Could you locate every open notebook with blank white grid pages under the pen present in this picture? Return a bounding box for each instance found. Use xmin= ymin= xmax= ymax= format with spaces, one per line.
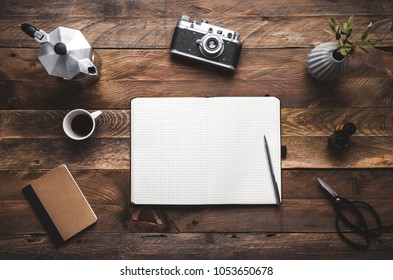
xmin=131 ymin=97 xmax=281 ymax=205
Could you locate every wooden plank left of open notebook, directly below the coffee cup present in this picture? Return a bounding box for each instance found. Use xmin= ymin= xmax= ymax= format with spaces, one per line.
xmin=0 ymin=138 xmax=130 ymax=170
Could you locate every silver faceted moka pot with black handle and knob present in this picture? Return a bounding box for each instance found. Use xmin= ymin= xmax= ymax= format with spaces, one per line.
xmin=21 ymin=23 xmax=101 ymax=88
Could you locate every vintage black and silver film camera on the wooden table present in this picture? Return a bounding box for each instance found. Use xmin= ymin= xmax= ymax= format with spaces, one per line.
xmin=169 ymin=15 xmax=242 ymax=71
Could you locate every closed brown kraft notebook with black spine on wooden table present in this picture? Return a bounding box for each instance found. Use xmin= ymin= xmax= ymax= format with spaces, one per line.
xmin=23 ymin=164 xmax=97 ymax=243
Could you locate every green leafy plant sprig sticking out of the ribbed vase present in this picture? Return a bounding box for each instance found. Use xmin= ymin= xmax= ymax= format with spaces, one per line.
xmin=324 ymin=16 xmax=381 ymax=57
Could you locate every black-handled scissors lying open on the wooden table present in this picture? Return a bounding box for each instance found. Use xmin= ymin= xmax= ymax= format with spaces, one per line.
xmin=317 ymin=178 xmax=382 ymax=249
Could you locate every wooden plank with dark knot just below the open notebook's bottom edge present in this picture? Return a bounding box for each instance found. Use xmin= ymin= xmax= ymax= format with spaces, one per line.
xmin=0 ymin=199 xmax=393 ymax=234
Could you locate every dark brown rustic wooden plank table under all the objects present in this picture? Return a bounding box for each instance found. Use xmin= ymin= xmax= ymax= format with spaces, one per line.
xmin=0 ymin=0 xmax=393 ymax=259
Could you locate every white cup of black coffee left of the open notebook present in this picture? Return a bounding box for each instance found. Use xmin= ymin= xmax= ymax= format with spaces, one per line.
xmin=63 ymin=109 xmax=102 ymax=140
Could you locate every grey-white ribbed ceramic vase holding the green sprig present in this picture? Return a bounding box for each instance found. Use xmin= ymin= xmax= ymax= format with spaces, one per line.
xmin=307 ymin=42 xmax=349 ymax=82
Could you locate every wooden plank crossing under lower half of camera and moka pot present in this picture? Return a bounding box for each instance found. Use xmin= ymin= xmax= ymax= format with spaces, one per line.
xmin=0 ymin=48 xmax=393 ymax=83
